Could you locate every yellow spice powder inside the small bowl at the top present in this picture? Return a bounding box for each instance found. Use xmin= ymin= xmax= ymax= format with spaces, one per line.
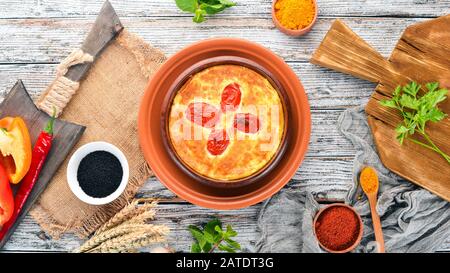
xmin=275 ymin=0 xmax=315 ymax=30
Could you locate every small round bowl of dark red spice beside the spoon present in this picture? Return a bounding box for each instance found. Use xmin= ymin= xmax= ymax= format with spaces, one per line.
xmin=313 ymin=203 xmax=363 ymax=253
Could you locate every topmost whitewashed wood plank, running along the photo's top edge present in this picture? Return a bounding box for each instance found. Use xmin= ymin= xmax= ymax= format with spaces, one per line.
xmin=0 ymin=0 xmax=450 ymax=18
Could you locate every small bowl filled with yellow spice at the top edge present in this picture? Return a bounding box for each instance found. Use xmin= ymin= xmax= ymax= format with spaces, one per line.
xmin=272 ymin=0 xmax=318 ymax=36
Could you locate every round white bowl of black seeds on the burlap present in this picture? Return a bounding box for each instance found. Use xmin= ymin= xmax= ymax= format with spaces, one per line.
xmin=67 ymin=141 xmax=129 ymax=205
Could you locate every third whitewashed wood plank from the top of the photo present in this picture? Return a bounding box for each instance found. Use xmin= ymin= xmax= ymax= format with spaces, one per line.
xmin=0 ymin=63 xmax=375 ymax=109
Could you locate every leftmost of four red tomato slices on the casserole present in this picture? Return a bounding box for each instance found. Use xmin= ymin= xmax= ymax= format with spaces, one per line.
xmin=185 ymin=102 xmax=220 ymax=128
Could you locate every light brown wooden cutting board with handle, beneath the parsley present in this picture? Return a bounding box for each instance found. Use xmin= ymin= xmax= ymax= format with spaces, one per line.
xmin=311 ymin=15 xmax=450 ymax=201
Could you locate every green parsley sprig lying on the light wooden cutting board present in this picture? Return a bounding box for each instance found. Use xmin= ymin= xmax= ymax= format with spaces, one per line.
xmin=380 ymin=82 xmax=450 ymax=164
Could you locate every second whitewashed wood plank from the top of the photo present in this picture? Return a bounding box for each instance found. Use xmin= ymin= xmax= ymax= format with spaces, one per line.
xmin=0 ymin=17 xmax=424 ymax=63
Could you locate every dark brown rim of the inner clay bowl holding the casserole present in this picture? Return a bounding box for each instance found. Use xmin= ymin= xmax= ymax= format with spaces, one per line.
xmin=161 ymin=55 xmax=290 ymax=188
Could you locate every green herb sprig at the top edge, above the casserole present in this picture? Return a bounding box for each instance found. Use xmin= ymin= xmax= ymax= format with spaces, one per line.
xmin=175 ymin=0 xmax=236 ymax=23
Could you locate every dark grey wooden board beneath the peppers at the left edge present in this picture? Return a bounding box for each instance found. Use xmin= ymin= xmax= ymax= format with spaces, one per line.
xmin=0 ymin=81 xmax=85 ymax=248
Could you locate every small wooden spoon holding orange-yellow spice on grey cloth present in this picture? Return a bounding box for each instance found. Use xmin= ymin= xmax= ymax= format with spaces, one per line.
xmin=359 ymin=167 xmax=385 ymax=253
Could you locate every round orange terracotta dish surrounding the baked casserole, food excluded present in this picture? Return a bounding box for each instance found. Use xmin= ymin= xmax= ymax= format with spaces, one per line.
xmin=138 ymin=38 xmax=311 ymax=209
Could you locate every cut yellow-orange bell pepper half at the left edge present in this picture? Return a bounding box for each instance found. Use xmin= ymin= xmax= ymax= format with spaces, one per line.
xmin=0 ymin=117 xmax=31 ymax=184
